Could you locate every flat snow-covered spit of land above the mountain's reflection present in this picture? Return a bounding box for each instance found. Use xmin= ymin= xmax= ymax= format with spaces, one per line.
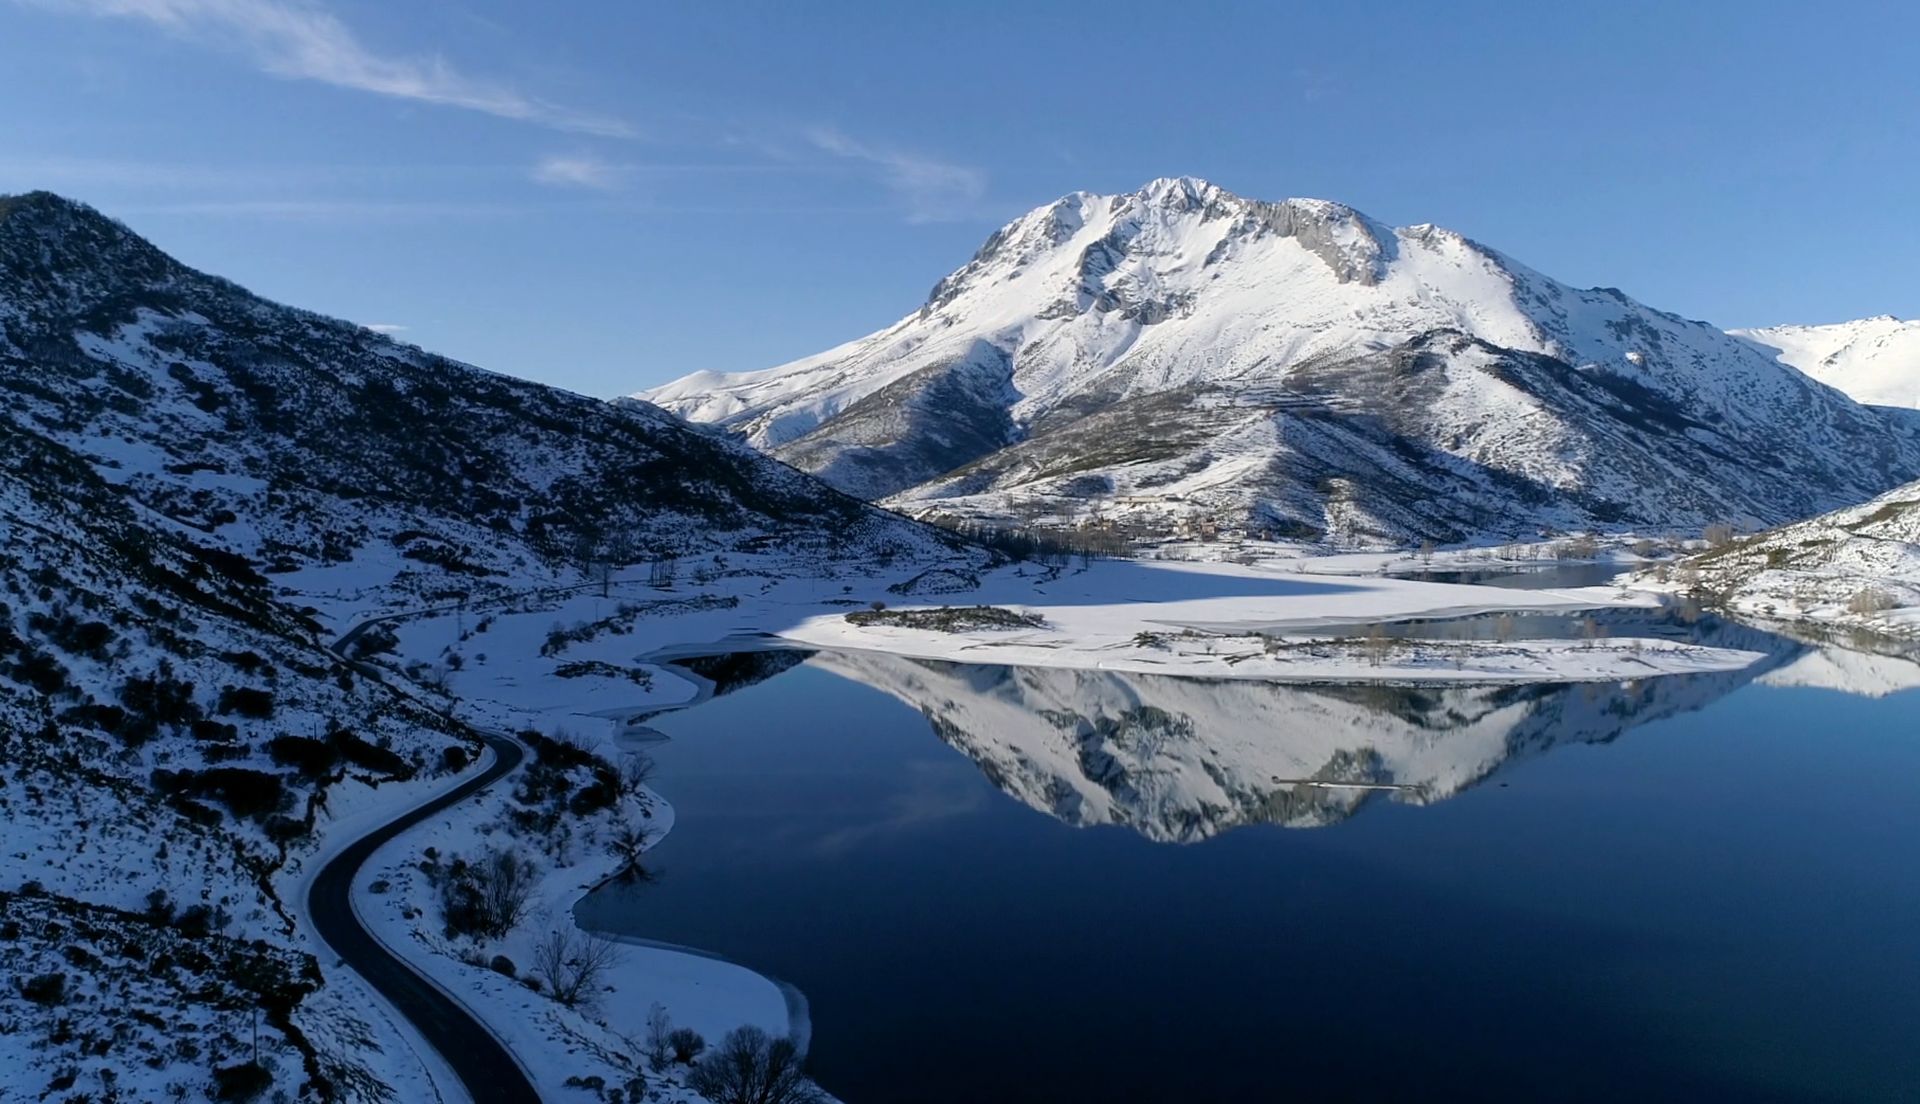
xmin=778 ymin=563 xmax=1759 ymax=682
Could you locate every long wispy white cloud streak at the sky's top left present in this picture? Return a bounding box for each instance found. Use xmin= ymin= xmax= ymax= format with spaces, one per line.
xmin=15 ymin=0 xmax=634 ymax=138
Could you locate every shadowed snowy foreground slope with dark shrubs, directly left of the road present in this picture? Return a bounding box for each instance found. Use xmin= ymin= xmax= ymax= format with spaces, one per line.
xmin=0 ymin=419 xmax=470 ymax=1100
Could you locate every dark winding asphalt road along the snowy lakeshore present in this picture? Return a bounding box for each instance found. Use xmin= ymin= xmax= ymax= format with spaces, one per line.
xmin=307 ymin=622 xmax=540 ymax=1104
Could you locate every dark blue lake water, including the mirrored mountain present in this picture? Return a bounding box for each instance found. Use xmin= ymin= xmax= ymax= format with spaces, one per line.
xmin=582 ymin=643 xmax=1920 ymax=1104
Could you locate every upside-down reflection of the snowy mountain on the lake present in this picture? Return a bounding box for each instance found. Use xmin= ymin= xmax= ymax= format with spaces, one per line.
xmin=810 ymin=624 xmax=1803 ymax=843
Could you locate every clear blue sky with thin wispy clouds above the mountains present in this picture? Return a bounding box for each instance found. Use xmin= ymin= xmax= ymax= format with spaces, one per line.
xmin=0 ymin=0 xmax=1920 ymax=396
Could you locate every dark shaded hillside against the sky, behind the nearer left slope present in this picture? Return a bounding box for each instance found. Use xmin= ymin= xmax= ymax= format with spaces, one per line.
xmin=0 ymin=192 xmax=960 ymax=618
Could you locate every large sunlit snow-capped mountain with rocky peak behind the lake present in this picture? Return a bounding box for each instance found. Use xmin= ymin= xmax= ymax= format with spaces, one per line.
xmin=645 ymin=179 xmax=1920 ymax=541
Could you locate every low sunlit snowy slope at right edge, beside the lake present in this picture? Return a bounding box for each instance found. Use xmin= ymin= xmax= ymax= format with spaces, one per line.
xmin=1653 ymin=482 xmax=1920 ymax=636
